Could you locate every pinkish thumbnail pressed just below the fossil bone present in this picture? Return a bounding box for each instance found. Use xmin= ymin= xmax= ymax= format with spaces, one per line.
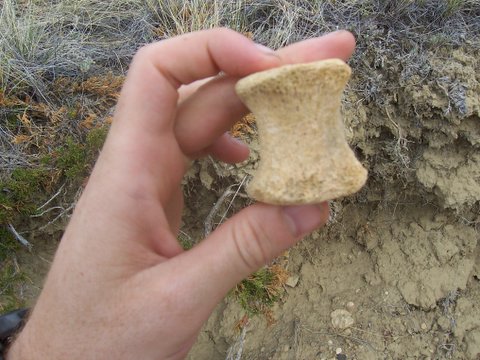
xmin=283 ymin=203 xmax=328 ymax=236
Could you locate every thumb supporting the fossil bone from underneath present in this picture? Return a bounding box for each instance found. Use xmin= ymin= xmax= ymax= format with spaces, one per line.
xmin=183 ymin=202 xmax=329 ymax=301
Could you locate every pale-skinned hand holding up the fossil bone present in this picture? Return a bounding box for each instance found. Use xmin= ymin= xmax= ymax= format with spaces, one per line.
xmin=7 ymin=29 xmax=355 ymax=360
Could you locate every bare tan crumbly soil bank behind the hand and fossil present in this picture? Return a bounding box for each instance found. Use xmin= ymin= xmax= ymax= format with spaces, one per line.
xmin=11 ymin=49 xmax=480 ymax=360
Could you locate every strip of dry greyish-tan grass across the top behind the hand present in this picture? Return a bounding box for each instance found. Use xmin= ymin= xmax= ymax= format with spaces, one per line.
xmin=0 ymin=0 xmax=480 ymax=167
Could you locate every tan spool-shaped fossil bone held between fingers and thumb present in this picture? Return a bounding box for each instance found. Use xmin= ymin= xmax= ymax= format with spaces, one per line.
xmin=236 ymin=59 xmax=367 ymax=205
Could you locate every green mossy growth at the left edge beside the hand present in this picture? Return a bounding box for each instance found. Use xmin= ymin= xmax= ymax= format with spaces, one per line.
xmin=0 ymin=127 xmax=107 ymax=313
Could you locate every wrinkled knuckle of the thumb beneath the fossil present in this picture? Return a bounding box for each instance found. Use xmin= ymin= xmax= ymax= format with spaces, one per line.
xmin=232 ymin=216 xmax=271 ymax=271
